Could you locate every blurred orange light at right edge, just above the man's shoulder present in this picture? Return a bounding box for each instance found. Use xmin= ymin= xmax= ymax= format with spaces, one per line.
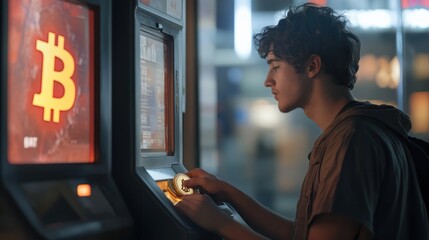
xmin=410 ymin=92 xmax=429 ymax=133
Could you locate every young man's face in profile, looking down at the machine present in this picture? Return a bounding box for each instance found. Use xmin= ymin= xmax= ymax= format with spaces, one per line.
xmin=264 ymin=51 xmax=312 ymax=112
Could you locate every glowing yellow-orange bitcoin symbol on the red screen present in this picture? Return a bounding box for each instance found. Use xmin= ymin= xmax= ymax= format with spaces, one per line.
xmin=33 ymin=32 xmax=76 ymax=123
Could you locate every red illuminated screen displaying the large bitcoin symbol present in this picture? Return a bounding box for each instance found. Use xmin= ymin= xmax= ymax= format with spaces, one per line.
xmin=7 ymin=0 xmax=95 ymax=164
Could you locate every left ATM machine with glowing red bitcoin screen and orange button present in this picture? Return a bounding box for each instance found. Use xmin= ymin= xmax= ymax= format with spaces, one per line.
xmin=0 ymin=0 xmax=133 ymax=239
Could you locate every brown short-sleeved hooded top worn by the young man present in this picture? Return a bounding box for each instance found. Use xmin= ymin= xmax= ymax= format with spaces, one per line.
xmin=292 ymin=104 xmax=429 ymax=240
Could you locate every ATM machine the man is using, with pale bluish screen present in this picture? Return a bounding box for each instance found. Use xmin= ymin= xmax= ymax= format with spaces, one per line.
xmin=112 ymin=0 xmax=233 ymax=239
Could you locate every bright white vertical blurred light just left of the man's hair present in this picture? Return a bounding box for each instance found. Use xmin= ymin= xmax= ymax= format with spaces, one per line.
xmin=234 ymin=0 xmax=252 ymax=59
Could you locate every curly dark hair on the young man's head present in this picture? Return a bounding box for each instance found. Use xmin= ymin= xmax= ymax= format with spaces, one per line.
xmin=253 ymin=3 xmax=361 ymax=89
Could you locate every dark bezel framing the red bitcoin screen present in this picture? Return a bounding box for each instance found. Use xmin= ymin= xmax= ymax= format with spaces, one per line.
xmin=0 ymin=0 xmax=112 ymax=181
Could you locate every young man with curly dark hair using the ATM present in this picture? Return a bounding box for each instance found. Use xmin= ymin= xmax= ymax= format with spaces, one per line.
xmin=176 ymin=4 xmax=429 ymax=240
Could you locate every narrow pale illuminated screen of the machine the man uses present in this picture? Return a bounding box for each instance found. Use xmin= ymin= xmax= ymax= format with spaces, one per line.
xmin=140 ymin=27 xmax=174 ymax=154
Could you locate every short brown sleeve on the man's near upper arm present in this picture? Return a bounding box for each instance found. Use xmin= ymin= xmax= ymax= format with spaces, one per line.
xmin=309 ymin=125 xmax=384 ymax=231
